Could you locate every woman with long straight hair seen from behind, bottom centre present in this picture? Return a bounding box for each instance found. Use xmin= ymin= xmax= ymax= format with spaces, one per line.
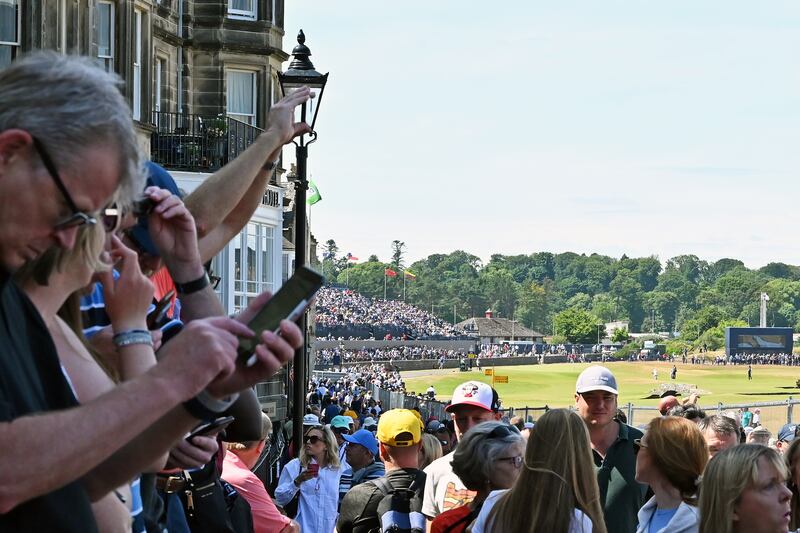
xmin=472 ymin=409 xmax=606 ymax=533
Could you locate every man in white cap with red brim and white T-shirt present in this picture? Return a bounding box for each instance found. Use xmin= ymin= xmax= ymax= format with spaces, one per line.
xmin=422 ymin=381 xmax=501 ymax=529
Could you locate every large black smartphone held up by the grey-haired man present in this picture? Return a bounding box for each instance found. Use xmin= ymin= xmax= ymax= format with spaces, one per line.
xmin=238 ymin=267 xmax=325 ymax=366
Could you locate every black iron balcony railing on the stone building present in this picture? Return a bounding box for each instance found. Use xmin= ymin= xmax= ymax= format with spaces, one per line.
xmin=150 ymin=111 xmax=263 ymax=172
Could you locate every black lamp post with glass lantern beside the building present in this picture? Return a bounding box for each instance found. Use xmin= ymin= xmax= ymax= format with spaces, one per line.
xmin=278 ymin=30 xmax=328 ymax=455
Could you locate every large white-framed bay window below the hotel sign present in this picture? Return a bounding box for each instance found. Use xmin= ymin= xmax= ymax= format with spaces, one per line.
xmin=233 ymin=222 xmax=275 ymax=312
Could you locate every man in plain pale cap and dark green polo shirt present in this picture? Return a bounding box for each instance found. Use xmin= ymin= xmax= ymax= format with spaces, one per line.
xmin=575 ymin=366 xmax=647 ymax=533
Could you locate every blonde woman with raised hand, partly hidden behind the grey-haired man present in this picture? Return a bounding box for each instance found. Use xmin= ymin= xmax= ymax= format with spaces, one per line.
xmin=15 ymin=214 xmax=166 ymax=532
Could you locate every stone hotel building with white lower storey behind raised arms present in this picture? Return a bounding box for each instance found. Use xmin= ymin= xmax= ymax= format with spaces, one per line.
xmin=0 ymin=0 xmax=300 ymax=417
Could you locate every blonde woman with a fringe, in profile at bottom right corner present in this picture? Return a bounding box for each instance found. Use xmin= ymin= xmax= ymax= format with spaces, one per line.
xmin=699 ymin=444 xmax=792 ymax=533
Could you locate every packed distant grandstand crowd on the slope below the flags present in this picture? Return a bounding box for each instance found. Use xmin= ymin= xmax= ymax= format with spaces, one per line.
xmin=316 ymin=287 xmax=458 ymax=338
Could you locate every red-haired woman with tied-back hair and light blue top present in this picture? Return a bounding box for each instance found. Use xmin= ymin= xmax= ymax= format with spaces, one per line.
xmin=634 ymin=416 xmax=708 ymax=533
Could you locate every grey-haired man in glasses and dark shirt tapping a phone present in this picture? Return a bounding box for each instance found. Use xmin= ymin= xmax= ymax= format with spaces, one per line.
xmin=0 ymin=53 xmax=302 ymax=532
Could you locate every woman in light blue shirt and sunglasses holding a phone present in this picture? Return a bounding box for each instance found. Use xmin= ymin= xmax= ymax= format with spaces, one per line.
xmin=275 ymin=426 xmax=342 ymax=532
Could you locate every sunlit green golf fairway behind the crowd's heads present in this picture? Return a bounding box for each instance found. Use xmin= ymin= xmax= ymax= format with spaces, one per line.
xmin=403 ymin=362 xmax=800 ymax=410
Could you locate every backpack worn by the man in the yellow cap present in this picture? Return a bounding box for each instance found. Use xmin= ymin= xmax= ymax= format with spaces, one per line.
xmin=367 ymin=470 xmax=425 ymax=533
